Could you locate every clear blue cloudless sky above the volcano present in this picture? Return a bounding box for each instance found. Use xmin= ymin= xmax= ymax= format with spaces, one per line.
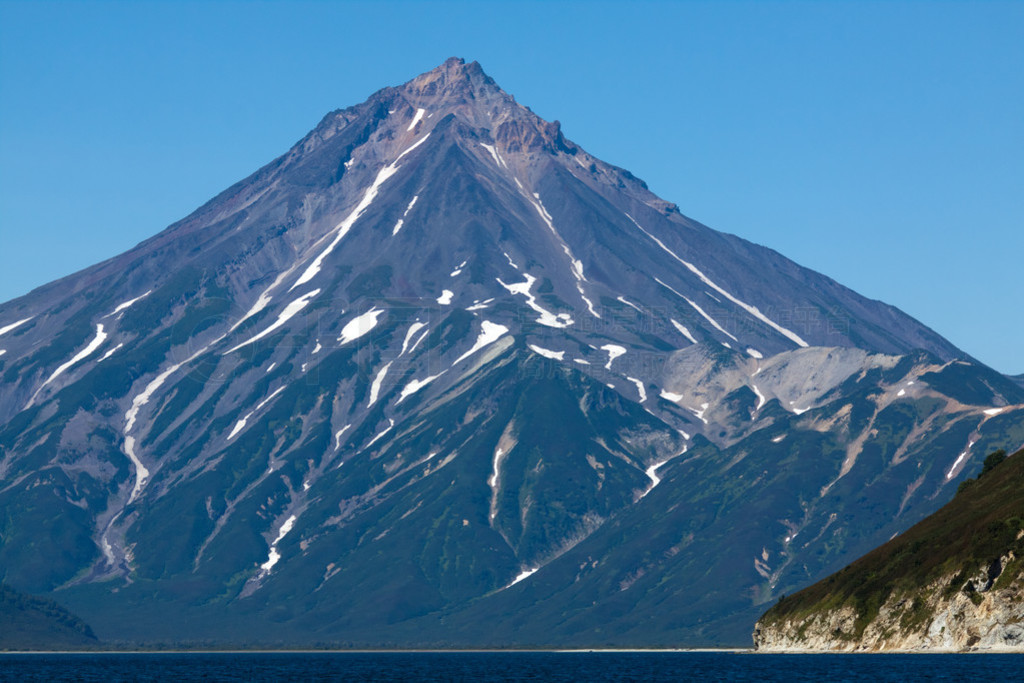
xmin=0 ymin=0 xmax=1024 ymax=373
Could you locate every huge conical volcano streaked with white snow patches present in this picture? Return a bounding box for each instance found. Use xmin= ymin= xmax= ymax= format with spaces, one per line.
xmin=0 ymin=59 xmax=1024 ymax=646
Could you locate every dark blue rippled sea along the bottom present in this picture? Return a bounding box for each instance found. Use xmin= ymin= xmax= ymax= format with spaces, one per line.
xmin=0 ymin=652 xmax=1024 ymax=683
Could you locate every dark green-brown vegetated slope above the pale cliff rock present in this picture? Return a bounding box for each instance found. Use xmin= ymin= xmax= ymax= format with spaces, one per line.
xmin=761 ymin=451 xmax=1024 ymax=635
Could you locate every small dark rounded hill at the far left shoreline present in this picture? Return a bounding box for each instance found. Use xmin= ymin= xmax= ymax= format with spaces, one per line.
xmin=0 ymin=584 xmax=98 ymax=650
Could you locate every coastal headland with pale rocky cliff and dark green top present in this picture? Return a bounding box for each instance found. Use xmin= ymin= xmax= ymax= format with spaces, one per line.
xmin=754 ymin=452 xmax=1024 ymax=652
